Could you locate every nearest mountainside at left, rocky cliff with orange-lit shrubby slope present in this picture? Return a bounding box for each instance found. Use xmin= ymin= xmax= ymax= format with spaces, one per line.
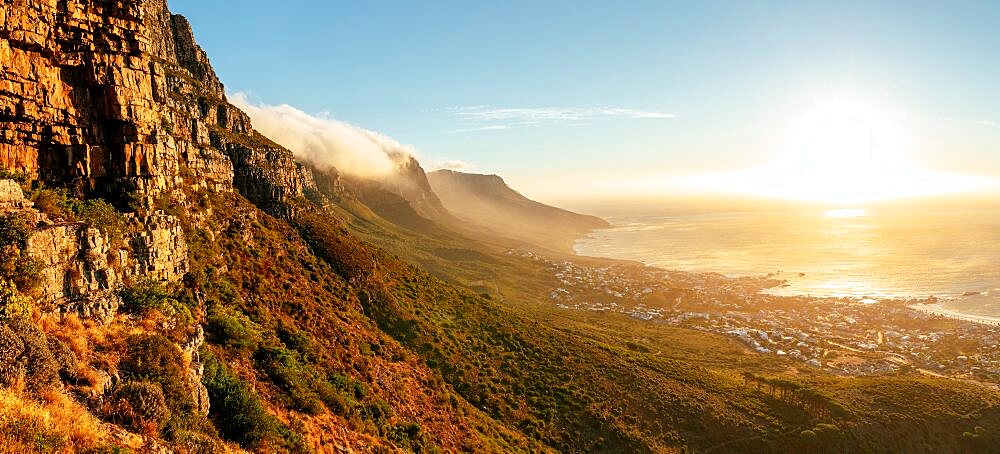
xmin=0 ymin=1 xmax=541 ymax=452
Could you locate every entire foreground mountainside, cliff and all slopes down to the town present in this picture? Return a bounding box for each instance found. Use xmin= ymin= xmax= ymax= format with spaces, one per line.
xmin=0 ymin=0 xmax=1000 ymax=453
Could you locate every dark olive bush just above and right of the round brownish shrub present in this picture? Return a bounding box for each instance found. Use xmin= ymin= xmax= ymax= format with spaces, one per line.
xmin=118 ymin=335 xmax=194 ymax=415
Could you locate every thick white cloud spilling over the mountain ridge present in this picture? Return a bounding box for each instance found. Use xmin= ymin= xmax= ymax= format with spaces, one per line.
xmin=230 ymin=93 xmax=416 ymax=178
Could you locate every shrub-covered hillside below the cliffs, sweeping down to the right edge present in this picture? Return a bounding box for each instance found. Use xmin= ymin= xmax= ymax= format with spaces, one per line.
xmin=0 ymin=168 xmax=1000 ymax=452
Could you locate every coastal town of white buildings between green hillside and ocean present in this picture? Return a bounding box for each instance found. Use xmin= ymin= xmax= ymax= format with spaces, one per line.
xmin=508 ymin=251 xmax=1000 ymax=387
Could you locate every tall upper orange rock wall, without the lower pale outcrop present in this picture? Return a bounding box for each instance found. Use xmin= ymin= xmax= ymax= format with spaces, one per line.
xmin=0 ymin=0 xmax=302 ymax=212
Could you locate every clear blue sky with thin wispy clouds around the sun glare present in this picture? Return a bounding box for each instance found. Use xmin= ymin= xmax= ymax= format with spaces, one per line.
xmin=170 ymin=0 xmax=1000 ymax=199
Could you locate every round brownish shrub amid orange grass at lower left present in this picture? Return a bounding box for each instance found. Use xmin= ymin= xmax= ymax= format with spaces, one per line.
xmin=105 ymin=381 xmax=170 ymax=434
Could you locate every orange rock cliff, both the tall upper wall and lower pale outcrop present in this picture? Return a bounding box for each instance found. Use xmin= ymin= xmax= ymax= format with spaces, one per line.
xmin=0 ymin=0 xmax=308 ymax=319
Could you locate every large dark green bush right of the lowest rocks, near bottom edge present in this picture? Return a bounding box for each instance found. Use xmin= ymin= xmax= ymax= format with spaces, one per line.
xmin=201 ymin=349 xmax=280 ymax=448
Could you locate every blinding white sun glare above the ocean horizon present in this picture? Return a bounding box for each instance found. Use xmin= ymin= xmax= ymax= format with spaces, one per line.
xmin=686 ymin=100 xmax=987 ymax=204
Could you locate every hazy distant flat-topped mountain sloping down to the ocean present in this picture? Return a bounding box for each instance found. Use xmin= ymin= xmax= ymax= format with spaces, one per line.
xmin=427 ymin=170 xmax=610 ymax=251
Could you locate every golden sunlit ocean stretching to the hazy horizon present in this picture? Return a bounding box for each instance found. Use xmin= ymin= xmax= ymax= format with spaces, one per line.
xmin=576 ymin=200 xmax=1000 ymax=317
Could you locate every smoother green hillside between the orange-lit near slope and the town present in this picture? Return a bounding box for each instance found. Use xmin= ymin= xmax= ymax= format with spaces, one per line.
xmin=306 ymin=183 xmax=998 ymax=452
